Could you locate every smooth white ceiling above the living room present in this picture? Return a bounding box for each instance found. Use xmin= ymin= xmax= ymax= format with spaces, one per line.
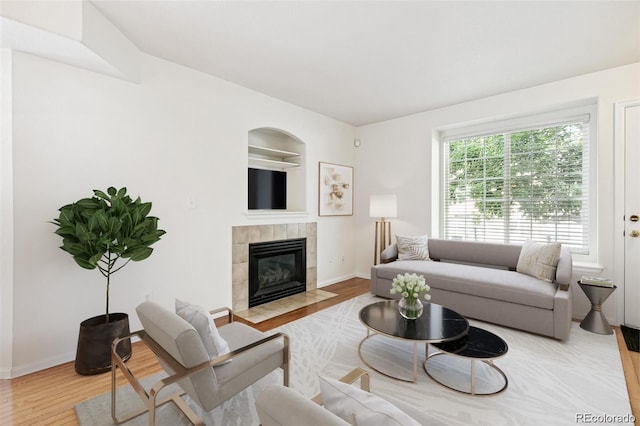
xmin=91 ymin=0 xmax=640 ymax=126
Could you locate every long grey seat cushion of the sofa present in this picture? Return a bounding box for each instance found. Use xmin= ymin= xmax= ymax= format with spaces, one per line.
xmin=376 ymin=260 xmax=556 ymax=309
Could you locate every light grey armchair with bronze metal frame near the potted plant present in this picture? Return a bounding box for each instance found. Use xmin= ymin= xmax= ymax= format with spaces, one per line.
xmin=111 ymin=302 xmax=290 ymax=425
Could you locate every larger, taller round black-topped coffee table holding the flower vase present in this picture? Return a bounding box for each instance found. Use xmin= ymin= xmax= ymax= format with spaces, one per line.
xmin=358 ymin=300 xmax=469 ymax=383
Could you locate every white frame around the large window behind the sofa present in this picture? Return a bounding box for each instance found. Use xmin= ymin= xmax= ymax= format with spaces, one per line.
xmin=433 ymin=104 xmax=598 ymax=262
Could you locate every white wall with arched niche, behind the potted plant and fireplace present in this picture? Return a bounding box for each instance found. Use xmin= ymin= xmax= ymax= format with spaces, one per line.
xmin=0 ymin=52 xmax=356 ymax=377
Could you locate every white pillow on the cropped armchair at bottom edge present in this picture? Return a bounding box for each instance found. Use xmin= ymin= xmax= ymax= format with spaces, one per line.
xmin=320 ymin=376 xmax=420 ymax=426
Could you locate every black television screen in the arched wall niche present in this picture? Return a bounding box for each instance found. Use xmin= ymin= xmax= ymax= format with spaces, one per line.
xmin=249 ymin=168 xmax=287 ymax=210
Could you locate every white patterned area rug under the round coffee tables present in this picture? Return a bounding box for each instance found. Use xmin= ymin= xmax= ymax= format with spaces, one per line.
xmin=76 ymin=295 xmax=631 ymax=426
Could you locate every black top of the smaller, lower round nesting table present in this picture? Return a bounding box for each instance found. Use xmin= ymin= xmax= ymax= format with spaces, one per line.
xmin=433 ymin=326 xmax=509 ymax=359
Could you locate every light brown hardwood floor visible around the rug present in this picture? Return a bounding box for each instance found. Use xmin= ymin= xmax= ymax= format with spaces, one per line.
xmin=0 ymin=278 xmax=640 ymax=425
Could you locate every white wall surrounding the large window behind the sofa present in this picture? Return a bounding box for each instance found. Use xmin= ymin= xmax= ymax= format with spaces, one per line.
xmin=356 ymin=64 xmax=640 ymax=324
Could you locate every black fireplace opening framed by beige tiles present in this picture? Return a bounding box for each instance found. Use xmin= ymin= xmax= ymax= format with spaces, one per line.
xmin=249 ymin=238 xmax=307 ymax=308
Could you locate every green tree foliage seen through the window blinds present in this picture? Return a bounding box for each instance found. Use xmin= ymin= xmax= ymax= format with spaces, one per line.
xmin=448 ymin=123 xmax=583 ymax=221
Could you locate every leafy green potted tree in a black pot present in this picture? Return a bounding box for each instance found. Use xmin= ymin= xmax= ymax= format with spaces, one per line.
xmin=51 ymin=187 xmax=165 ymax=375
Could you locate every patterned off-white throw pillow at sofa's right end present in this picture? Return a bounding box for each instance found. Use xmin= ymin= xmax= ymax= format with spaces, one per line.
xmin=516 ymin=241 xmax=562 ymax=283
